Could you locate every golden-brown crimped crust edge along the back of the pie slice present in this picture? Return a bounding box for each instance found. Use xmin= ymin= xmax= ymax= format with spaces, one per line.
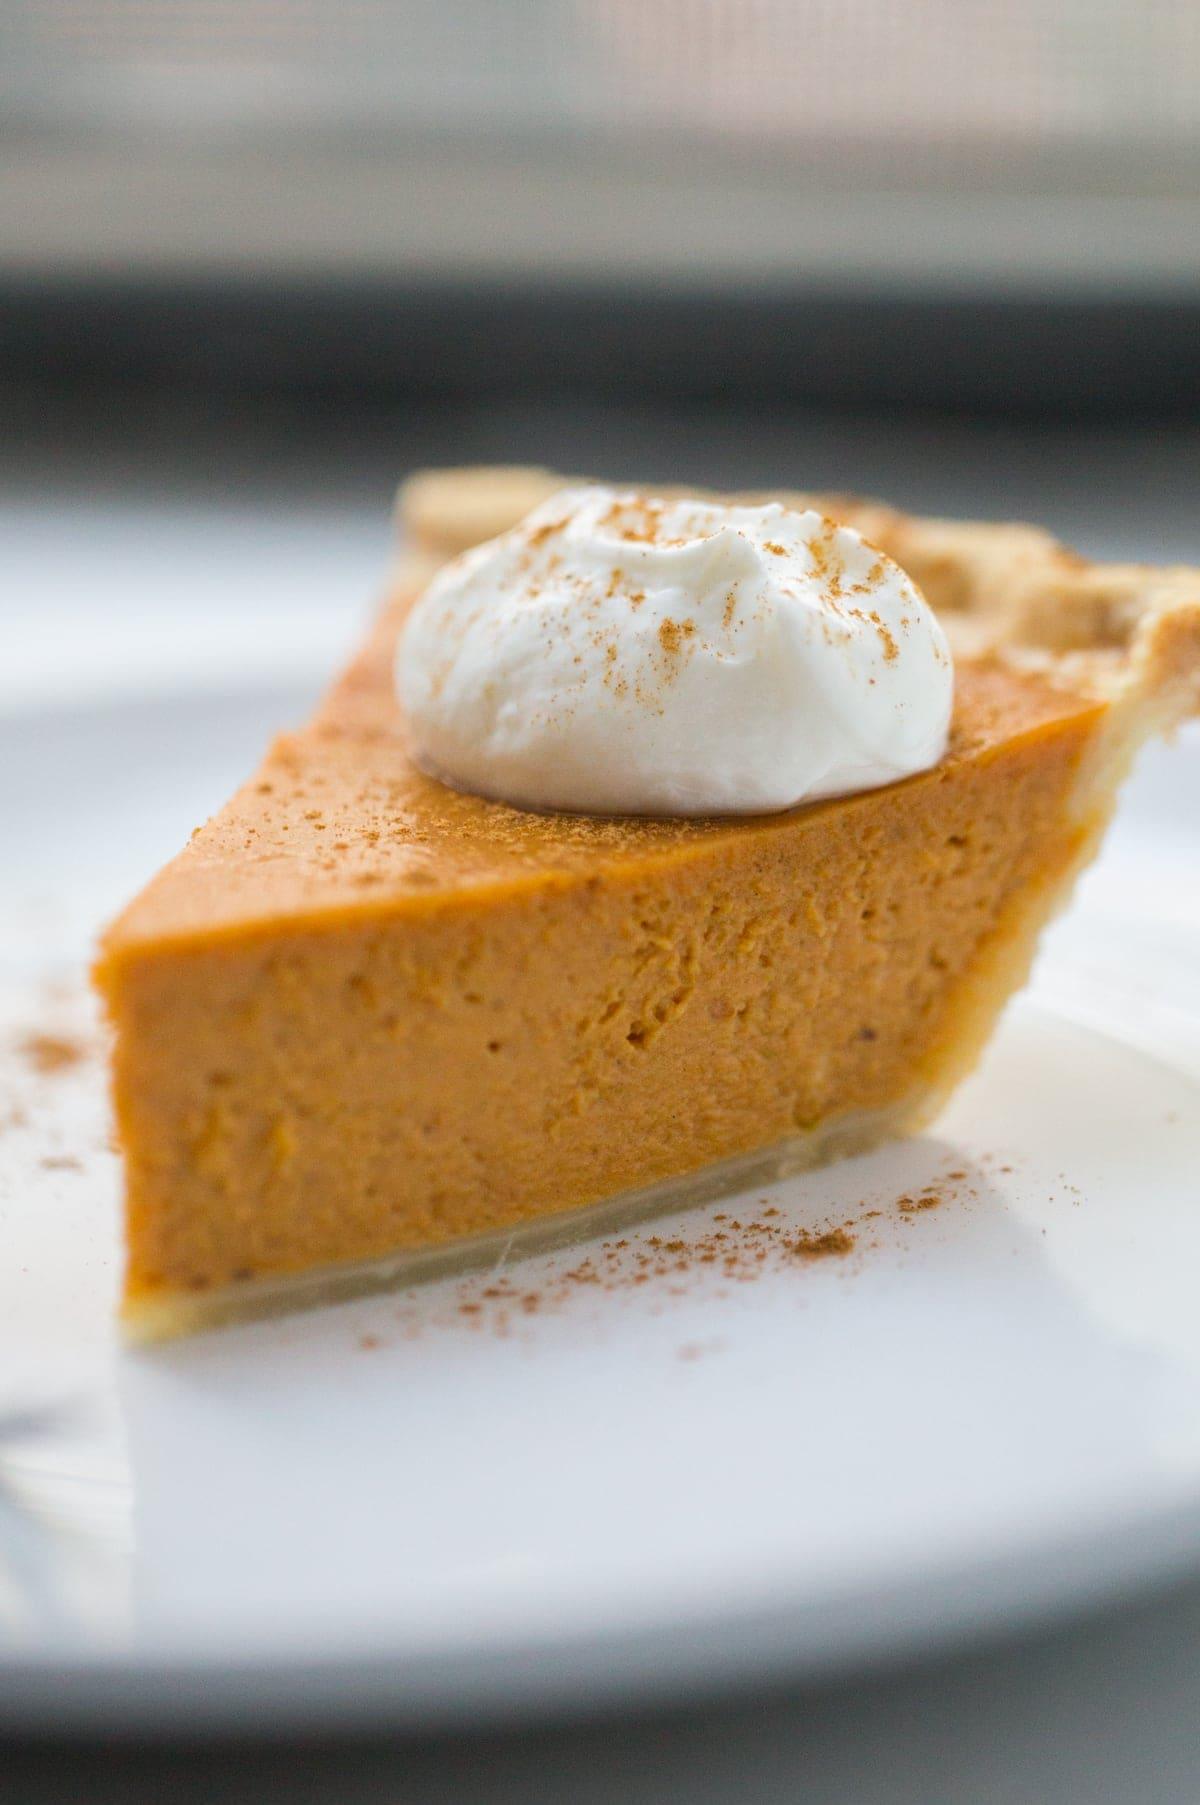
xmin=397 ymin=464 xmax=1200 ymax=733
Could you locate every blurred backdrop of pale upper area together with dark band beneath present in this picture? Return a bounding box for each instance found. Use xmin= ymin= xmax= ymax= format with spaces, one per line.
xmin=0 ymin=0 xmax=1200 ymax=400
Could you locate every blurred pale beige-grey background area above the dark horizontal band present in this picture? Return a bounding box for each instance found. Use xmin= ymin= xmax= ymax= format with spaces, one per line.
xmin=0 ymin=0 xmax=1200 ymax=292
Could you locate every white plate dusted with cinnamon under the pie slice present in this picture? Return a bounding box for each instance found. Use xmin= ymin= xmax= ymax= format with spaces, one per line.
xmin=0 ymin=695 xmax=1200 ymax=1727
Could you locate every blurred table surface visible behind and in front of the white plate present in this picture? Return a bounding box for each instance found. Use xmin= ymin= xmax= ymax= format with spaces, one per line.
xmin=9 ymin=395 xmax=1200 ymax=1805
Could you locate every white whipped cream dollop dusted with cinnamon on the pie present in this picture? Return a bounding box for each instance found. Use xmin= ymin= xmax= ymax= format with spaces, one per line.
xmin=397 ymin=487 xmax=953 ymax=814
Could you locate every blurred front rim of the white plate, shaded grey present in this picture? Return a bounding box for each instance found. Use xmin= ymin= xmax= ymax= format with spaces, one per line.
xmin=0 ymin=1496 xmax=1200 ymax=1736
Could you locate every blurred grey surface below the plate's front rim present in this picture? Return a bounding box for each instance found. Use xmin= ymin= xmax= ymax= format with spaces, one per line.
xmin=0 ymin=1583 xmax=1200 ymax=1805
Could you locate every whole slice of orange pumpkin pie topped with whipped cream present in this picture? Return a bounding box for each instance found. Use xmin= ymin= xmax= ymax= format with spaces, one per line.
xmin=96 ymin=469 xmax=1200 ymax=1336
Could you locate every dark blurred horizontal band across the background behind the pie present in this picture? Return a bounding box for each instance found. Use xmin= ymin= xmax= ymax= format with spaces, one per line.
xmin=0 ymin=276 xmax=1200 ymax=419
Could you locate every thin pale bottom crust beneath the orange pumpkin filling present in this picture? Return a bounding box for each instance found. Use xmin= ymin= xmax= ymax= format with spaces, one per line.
xmin=121 ymin=1092 xmax=923 ymax=1345
